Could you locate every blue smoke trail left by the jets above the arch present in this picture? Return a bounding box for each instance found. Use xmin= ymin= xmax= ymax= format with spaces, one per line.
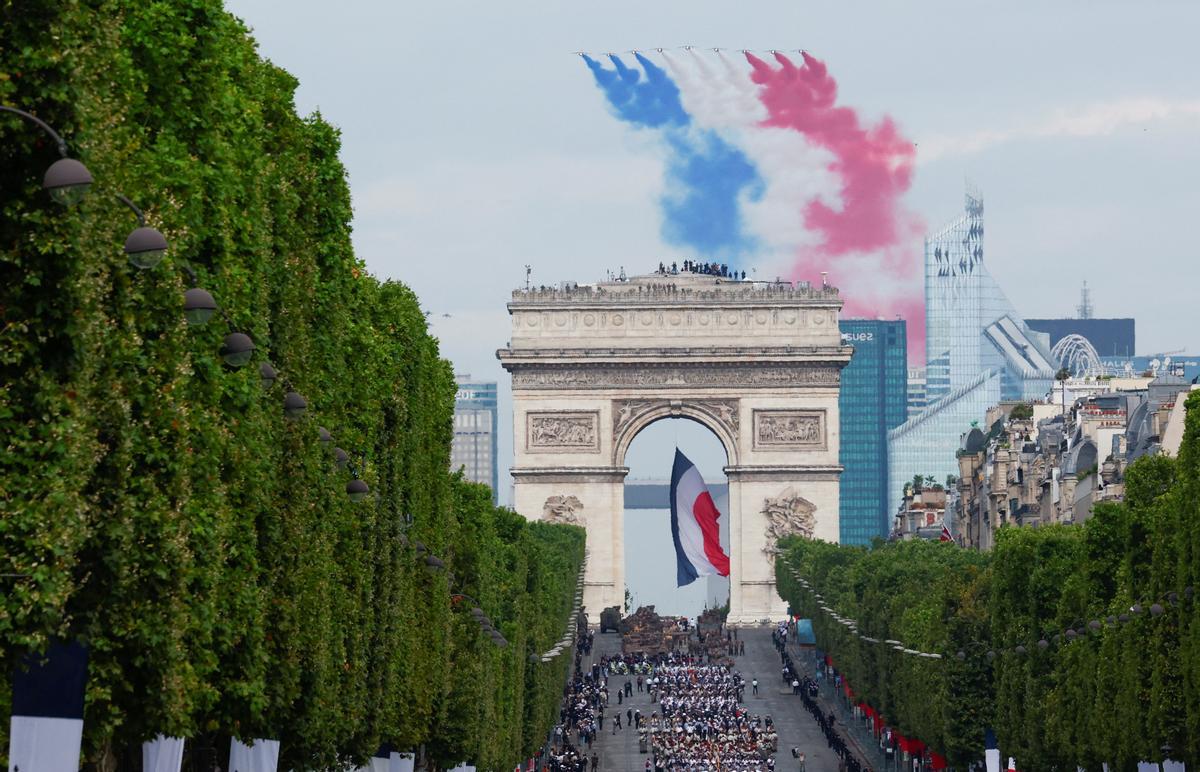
xmin=583 ymin=54 xmax=763 ymax=264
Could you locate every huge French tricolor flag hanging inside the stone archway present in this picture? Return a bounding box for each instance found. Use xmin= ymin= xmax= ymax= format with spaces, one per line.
xmin=671 ymin=448 xmax=730 ymax=587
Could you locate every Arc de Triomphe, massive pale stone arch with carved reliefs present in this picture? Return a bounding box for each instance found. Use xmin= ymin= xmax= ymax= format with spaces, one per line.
xmin=497 ymin=274 xmax=851 ymax=622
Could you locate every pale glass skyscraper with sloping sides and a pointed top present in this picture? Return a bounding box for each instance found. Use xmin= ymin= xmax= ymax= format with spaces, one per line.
xmin=888 ymin=192 xmax=1056 ymax=509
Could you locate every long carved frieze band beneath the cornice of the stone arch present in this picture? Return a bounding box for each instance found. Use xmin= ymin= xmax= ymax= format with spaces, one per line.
xmin=512 ymin=363 xmax=841 ymax=389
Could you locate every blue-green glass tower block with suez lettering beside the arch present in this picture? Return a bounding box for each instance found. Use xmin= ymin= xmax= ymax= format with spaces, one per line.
xmin=838 ymin=319 xmax=908 ymax=544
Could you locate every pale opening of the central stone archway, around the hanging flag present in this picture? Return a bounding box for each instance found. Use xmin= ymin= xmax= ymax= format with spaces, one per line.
xmin=624 ymin=418 xmax=730 ymax=618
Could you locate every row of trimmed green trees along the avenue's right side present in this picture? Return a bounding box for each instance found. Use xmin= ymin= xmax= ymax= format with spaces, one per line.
xmin=778 ymin=393 xmax=1200 ymax=770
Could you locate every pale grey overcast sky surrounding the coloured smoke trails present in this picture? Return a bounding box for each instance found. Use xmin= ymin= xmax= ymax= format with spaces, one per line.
xmin=228 ymin=0 xmax=1200 ymax=504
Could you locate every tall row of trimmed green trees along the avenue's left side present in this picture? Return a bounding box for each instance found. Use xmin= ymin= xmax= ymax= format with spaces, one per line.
xmin=0 ymin=0 xmax=583 ymax=770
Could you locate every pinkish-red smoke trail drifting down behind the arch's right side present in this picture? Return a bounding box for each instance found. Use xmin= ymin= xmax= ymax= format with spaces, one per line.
xmin=746 ymin=53 xmax=925 ymax=363
